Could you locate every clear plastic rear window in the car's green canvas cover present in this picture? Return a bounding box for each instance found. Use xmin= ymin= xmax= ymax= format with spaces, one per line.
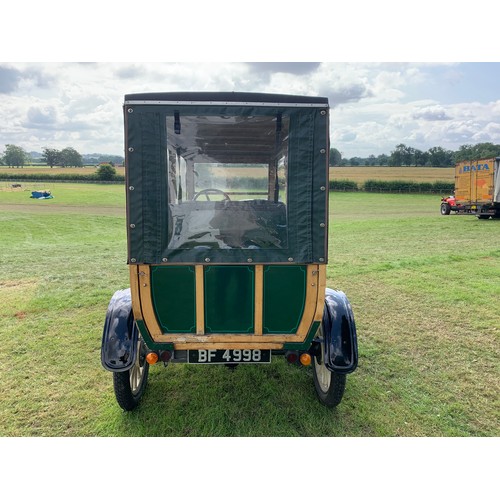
xmin=167 ymin=113 xmax=289 ymax=249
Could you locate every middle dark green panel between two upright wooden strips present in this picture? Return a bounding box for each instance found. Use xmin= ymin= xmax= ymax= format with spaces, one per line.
xmin=204 ymin=266 xmax=255 ymax=333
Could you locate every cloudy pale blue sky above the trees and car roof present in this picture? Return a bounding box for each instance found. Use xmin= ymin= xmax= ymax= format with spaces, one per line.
xmin=0 ymin=62 xmax=500 ymax=157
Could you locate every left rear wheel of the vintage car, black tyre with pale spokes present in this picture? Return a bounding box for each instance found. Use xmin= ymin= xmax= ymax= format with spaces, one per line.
xmin=113 ymin=338 xmax=149 ymax=411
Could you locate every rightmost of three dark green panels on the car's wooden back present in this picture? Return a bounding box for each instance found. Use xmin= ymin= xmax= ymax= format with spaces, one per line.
xmin=263 ymin=265 xmax=307 ymax=334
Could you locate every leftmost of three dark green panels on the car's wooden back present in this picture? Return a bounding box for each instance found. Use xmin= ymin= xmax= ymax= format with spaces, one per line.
xmin=151 ymin=266 xmax=196 ymax=333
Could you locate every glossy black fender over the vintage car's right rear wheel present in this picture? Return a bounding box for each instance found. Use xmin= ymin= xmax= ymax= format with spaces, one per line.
xmin=322 ymin=288 xmax=358 ymax=373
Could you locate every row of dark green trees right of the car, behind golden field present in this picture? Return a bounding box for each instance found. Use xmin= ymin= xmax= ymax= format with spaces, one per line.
xmin=330 ymin=142 xmax=500 ymax=167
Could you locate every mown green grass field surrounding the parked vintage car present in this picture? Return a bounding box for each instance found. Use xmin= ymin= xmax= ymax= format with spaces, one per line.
xmin=0 ymin=184 xmax=500 ymax=436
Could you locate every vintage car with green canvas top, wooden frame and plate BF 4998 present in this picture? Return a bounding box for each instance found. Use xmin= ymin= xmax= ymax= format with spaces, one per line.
xmin=101 ymin=92 xmax=358 ymax=411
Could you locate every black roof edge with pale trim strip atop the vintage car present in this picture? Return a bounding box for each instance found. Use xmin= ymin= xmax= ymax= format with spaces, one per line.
xmin=124 ymin=92 xmax=328 ymax=107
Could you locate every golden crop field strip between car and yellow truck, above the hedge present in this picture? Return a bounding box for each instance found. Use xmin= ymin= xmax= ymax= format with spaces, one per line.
xmin=330 ymin=167 xmax=455 ymax=187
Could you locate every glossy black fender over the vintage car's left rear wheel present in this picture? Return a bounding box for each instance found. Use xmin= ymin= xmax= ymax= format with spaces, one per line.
xmin=101 ymin=288 xmax=139 ymax=372
